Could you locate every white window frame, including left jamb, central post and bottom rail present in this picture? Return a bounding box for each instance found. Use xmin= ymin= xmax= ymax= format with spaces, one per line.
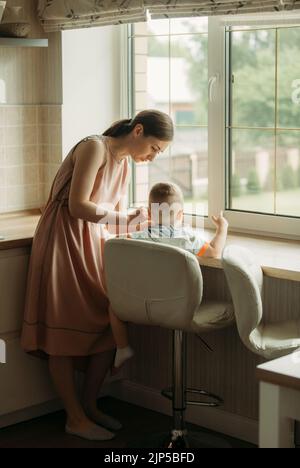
xmin=120 ymin=14 xmax=300 ymax=240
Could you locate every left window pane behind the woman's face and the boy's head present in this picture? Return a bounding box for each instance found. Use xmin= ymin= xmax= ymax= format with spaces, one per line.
xmin=130 ymin=18 xmax=208 ymax=215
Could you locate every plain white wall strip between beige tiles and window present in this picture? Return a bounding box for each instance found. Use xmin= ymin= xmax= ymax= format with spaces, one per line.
xmin=62 ymin=26 xmax=120 ymax=156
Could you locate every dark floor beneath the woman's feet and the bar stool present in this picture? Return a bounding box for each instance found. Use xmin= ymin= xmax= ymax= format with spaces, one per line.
xmin=0 ymin=398 xmax=256 ymax=448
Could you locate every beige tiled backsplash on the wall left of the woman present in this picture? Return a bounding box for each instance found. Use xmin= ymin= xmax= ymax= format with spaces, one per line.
xmin=0 ymin=105 xmax=62 ymax=213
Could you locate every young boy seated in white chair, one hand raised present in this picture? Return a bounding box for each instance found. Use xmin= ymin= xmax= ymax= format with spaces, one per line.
xmin=110 ymin=183 xmax=228 ymax=370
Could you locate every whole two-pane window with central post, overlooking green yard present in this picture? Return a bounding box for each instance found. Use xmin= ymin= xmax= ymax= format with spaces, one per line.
xmin=128 ymin=15 xmax=300 ymax=237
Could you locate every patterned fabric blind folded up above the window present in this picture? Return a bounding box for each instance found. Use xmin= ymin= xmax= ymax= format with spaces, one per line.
xmin=38 ymin=0 xmax=300 ymax=32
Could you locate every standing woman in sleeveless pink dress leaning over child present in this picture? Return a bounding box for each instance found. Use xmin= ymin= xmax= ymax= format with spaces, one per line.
xmin=22 ymin=110 xmax=174 ymax=440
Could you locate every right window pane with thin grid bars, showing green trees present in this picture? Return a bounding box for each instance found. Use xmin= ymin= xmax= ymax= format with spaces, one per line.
xmin=227 ymin=23 xmax=300 ymax=217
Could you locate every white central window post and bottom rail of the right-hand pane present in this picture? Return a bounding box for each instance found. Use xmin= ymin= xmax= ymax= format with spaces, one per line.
xmin=206 ymin=16 xmax=300 ymax=239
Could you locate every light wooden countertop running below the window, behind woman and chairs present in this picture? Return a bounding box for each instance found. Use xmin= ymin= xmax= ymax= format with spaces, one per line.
xmin=0 ymin=210 xmax=300 ymax=282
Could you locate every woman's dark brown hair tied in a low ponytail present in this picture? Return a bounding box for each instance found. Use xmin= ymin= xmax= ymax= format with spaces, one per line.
xmin=103 ymin=110 xmax=174 ymax=141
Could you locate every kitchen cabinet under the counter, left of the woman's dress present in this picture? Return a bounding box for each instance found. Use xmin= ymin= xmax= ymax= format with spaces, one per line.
xmin=0 ymin=248 xmax=56 ymax=428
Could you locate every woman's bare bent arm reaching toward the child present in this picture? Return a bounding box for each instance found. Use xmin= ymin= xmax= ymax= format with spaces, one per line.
xmin=69 ymin=140 xmax=127 ymax=224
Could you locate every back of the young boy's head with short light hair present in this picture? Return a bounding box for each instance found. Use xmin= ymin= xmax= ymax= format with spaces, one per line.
xmin=149 ymin=182 xmax=184 ymax=226
